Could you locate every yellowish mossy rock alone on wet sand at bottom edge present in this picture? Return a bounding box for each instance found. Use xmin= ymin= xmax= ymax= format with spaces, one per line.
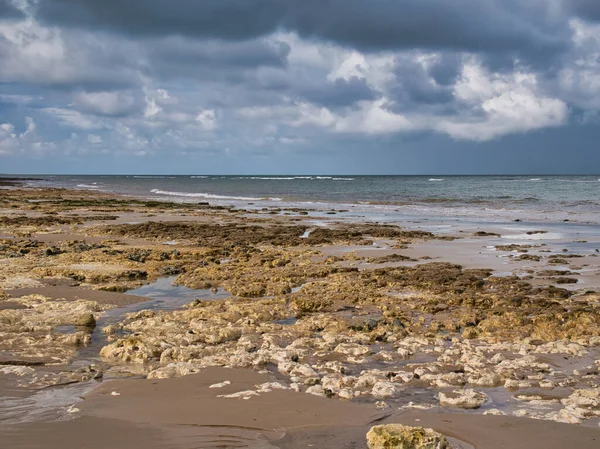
xmin=367 ymin=424 xmax=450 ymax=449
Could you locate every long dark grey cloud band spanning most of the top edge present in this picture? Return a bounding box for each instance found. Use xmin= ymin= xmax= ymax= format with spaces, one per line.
xmin=38 ymin=0 xmax=569 ymax=56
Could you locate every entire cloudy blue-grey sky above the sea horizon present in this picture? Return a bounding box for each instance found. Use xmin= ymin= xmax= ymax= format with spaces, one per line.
xmin=0 ymin=0 xmax=600 ymax=174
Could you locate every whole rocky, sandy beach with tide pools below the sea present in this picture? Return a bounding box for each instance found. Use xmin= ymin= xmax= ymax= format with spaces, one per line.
xmin=0 ymin=185 xmax=600 ymax=449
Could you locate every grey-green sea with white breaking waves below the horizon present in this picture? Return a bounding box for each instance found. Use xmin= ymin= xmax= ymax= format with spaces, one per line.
xmin=7 ymin=175 xmax=600 ymax=223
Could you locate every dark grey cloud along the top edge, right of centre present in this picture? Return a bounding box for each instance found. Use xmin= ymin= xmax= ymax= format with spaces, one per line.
xmin=286 ymin=0 xmax=565 ymax=57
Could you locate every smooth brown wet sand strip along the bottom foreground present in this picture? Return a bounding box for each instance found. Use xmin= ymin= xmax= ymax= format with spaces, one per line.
xmin=0 ymin=368 xmax=600 ymax=449
